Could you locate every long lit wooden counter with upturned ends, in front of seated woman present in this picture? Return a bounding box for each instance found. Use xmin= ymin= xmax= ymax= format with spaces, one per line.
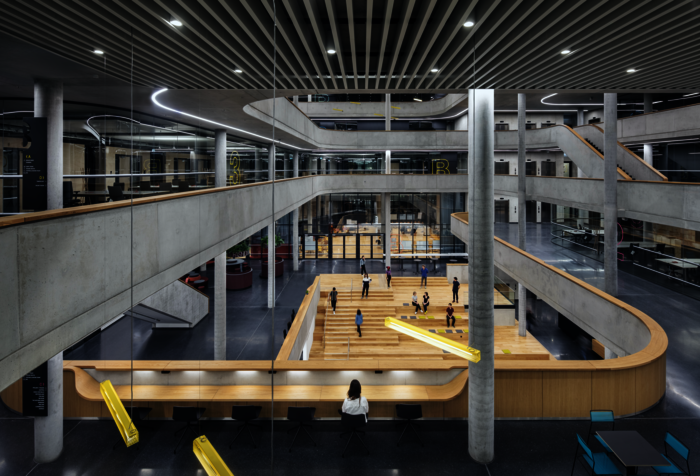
xmin=63 ymin=366 xmax=469 ymax=402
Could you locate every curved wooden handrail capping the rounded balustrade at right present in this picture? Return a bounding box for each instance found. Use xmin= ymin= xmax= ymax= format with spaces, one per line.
xmin=452 ymin=212 xmax=668 ymax=371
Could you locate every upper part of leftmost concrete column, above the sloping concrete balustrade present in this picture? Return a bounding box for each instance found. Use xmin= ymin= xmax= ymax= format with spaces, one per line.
xmin=34 ymin=79 xmax=63 ymax=210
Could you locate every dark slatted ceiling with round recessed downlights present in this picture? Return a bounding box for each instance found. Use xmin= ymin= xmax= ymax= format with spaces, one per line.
xmin=0 ymin=0 xmax=700 ymax=94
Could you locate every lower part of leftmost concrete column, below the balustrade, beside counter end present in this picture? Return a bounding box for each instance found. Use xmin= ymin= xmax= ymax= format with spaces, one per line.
xmin=34 ymin=352 xmax=63 ymax=463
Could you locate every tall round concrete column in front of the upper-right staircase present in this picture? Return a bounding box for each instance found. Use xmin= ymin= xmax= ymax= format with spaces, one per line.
xmin=603 ymin=93 xmax=617 ymax=296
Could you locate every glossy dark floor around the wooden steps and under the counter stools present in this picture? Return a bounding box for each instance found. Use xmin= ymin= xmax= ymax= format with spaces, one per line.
xmin=0 ymin=224 xmax=700 ymax=476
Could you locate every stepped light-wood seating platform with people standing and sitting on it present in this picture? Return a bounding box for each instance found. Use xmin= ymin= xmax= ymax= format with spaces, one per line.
xmin=309 ymin=273 xmax=554 ymax=361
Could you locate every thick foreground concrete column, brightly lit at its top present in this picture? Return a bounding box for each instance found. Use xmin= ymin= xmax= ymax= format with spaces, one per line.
xmin=468 ymin=89 xmax=494 ymax=464
